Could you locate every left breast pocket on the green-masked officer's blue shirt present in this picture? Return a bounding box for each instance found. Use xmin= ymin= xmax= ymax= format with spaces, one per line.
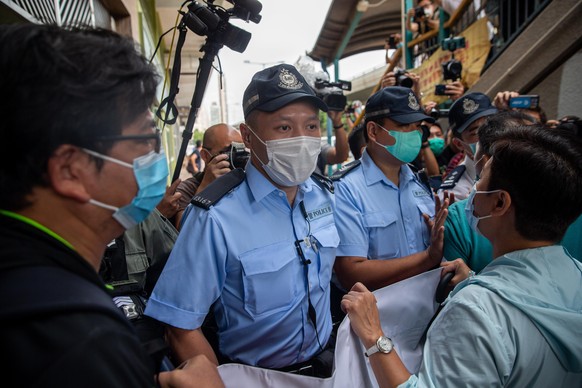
xmin=364 ymin=212 xmax=402 ymax=259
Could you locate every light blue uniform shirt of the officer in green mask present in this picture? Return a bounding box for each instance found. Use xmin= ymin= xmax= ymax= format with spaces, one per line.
xmin=335 ymin=151 xmax=434 ymax=260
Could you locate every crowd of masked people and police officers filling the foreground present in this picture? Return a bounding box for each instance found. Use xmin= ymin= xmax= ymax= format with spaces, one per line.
xmin=0 ymin=25 xmax=582 ymax=387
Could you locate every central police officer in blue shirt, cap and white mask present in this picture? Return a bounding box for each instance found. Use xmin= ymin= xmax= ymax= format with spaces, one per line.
xmin=146 ymin=64 xmax=339 ymax=376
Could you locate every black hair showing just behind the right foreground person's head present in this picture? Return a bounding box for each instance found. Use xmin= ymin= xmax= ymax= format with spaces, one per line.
xmin=478 ymin=110 xmax=535 ymax=156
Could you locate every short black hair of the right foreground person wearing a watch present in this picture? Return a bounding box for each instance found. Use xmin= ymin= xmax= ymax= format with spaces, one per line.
xmin=487 ymin=124 xmax=582 ymax=242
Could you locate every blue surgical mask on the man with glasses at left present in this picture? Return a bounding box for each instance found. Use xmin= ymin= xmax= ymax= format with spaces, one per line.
xmin=83 ymin=149 xmax=168 ymax=229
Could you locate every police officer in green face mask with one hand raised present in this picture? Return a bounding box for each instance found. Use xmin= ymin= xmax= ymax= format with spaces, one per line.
xmin=332 ymin=86 xmax=448 ymax=290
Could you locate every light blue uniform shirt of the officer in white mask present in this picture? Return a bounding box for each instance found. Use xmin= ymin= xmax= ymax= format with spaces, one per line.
xmin=146 ymin=163 xmax=339 ymax=368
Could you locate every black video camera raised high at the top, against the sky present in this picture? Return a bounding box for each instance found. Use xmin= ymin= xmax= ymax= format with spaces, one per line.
xmin=180 ymin=0 xmax=263 ymax=53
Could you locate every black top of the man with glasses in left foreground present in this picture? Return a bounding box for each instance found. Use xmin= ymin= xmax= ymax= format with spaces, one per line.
xmin=0 ymin=214 xmax=154 ymax=387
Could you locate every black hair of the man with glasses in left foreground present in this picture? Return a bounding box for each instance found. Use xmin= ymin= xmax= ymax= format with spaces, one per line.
xmin=0 ymin=24 xmax=158 ymax=210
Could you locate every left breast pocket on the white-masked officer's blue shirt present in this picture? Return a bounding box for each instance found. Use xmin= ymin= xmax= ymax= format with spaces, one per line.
xmin=239 ymin=241 xmax=303 ymax=316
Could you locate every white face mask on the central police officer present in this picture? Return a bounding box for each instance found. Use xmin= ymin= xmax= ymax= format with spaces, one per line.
xmin=247 ymin=125 xmax=321 ymax=187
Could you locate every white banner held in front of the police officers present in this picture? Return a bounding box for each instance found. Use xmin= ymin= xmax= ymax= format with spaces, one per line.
xmin=218 ymin=268 xmax=441 ymax=388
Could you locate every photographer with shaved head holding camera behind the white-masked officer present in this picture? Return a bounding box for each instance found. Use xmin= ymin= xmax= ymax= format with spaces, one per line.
xmin=174 ymin=124 xmax=244 ymax=230
